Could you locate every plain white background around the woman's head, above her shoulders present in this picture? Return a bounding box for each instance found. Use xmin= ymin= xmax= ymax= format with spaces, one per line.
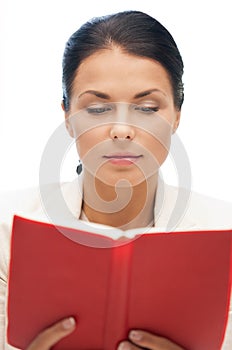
xmin=0 ymin=0 xmax=232 ymax=201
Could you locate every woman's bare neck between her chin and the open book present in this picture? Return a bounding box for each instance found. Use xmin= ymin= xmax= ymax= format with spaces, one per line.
xmin=82 ymin=172 xmax=158 ymax=230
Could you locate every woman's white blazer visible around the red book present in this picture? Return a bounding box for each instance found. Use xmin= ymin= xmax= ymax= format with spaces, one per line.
xmin=0 ymin=176 xmax=232 ymax=350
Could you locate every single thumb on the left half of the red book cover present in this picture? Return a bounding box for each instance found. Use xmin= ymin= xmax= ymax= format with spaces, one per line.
xmin=27 ymin=317 xmax=76 ymax=350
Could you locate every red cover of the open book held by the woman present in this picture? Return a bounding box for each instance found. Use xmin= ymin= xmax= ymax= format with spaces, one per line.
xmin=7 ymin=217 xmax=232 ymax=350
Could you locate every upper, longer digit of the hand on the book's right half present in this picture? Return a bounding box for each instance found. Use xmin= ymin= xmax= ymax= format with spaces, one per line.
xmin=129 ymin=330 xmax=184 ymax=350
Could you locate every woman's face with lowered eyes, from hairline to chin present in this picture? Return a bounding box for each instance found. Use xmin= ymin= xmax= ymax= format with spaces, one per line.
xmin=66 ymin=48 xmax=180 ymax=185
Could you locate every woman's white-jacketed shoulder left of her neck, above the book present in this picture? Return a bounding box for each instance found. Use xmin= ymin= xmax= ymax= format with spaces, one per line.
xmin=0 ymin=181 xmax=82 ymax=247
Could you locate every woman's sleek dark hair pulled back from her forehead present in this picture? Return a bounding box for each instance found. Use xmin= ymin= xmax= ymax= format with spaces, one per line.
xmin=63 ymin=11 xmax=184 ymax=111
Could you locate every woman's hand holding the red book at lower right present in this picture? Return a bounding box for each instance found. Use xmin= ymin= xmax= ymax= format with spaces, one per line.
xmin=118 ymin=330 xmax=184 ymax=350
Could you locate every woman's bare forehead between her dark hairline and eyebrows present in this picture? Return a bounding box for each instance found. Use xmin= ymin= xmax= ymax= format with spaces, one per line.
xmin=72 ymin=48 xmax=172 ymax=95
